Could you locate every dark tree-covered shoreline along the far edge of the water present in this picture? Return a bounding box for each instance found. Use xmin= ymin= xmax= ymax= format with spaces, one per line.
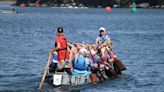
xmin=17 ymin=0 xmax=164 ymax=7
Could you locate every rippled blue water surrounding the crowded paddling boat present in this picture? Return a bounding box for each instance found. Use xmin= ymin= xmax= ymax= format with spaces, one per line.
xmin=0 ymin=6 xmax=164 ymax=92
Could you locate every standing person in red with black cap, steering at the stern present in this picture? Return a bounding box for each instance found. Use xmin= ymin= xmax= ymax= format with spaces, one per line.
xmin=53 ymin=27 xmax=69 ymax=70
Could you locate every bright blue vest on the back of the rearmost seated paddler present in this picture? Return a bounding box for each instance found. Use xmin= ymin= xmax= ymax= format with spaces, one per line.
xmin=73 ymin=55 xmax=90 ymax=70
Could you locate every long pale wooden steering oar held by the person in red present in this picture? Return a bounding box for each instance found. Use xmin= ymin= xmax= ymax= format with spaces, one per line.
xmin=38 ymin=49 xmax=52 ymax=90
